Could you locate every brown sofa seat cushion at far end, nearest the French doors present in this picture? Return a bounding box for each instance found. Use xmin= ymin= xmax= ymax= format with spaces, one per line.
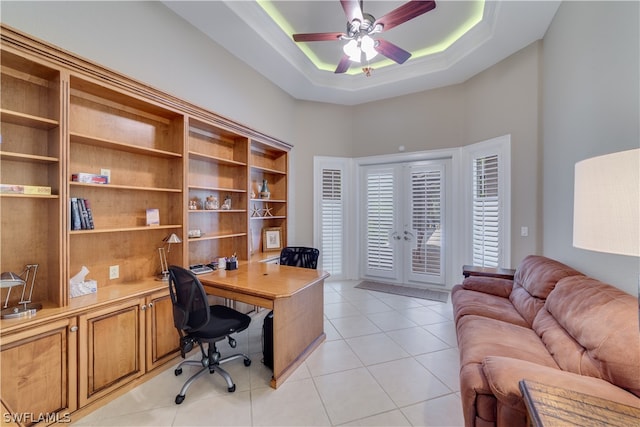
xmin=451 ymin=285 xmax=529 ymax=327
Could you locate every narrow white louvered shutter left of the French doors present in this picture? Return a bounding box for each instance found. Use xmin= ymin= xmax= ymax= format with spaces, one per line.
xmin=320 ymin=169 xmax=344 ymax=276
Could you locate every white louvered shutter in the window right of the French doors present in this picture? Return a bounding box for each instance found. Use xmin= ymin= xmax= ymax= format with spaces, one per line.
xmin=472 ymin=154 xmax=502 ymax=267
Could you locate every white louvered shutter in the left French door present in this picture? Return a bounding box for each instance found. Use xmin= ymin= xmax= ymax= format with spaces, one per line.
xmin=366 ymin=170 xmax=395 ymax=272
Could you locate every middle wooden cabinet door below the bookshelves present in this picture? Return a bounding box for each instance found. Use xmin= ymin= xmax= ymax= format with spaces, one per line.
xmin=79 ymin=298 xmax=146 ymax=406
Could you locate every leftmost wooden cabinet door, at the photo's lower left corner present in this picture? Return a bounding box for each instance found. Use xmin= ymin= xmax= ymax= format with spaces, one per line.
xmin=0 ymin=318 xmax=77 ymax=425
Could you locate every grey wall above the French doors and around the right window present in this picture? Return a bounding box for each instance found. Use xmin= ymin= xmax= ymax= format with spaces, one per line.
xmin=353 ymin=42 xmax=542 ymax=267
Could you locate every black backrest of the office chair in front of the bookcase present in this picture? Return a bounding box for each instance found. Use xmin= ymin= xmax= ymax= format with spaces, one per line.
xmin=169 ymin=265 xmax=210 ymax=332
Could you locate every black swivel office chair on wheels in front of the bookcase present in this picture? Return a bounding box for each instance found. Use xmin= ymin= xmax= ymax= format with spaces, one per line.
xmin=169 ymin=265 xmax=251 ymax=405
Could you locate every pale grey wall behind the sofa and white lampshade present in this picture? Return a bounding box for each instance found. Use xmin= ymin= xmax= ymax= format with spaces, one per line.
xmin=543 ymin=1 xmax=640 ymax=295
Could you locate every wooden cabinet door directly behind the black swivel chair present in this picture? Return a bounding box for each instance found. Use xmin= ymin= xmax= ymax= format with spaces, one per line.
xmin=146 ymin=289 xmax=180 ymax=371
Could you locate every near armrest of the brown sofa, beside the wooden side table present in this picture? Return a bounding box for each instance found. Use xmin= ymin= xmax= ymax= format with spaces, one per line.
xmin=482 ymin=356 xmax=640 ymax=411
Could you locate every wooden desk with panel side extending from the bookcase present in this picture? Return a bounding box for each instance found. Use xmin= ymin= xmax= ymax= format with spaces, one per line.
xmin=198 ymin=262 xmax=329 ymax=388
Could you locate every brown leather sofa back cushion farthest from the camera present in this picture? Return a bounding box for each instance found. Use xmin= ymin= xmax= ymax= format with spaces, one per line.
xmin=509 ymin=255 xmax=582 ymax=325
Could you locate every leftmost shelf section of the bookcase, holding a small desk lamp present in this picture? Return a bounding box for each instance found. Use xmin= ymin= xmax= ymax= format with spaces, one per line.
xmin=0 ymin=50 xmax=64 ymax=306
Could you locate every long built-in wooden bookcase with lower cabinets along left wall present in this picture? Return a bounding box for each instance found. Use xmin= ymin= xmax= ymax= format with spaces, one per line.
xmin=0 ymin=25 xmax=291 ymax=421
